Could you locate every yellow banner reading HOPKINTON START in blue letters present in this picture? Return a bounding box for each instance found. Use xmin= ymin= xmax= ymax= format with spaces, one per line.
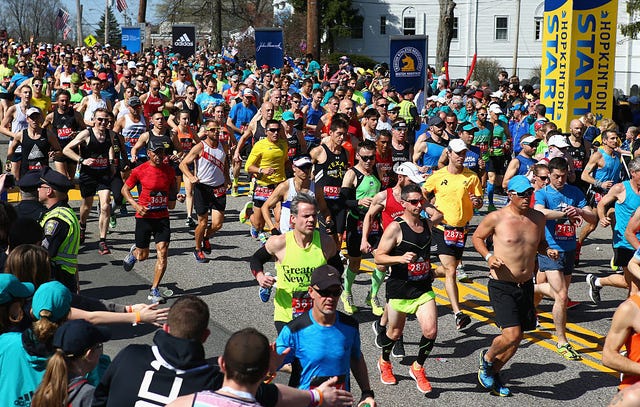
xmin=540 ymin=0 xmax=618 ymax=131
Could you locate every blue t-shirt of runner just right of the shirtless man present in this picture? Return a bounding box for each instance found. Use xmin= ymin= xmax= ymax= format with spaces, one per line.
xmin=536 ymin=184 xmax=587 ymax=252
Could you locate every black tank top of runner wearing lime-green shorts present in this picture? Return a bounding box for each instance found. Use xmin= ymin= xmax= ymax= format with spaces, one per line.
xmin=387 ymin=218 xmax=433 ymax=299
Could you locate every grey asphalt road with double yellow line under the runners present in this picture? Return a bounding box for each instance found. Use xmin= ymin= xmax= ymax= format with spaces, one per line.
xmin=67 ymin=191 xmax=625 ymax=406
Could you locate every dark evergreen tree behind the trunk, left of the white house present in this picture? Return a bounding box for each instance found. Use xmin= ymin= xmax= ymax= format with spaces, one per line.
xmin=291 ymin=0 xmax=362 ymax=53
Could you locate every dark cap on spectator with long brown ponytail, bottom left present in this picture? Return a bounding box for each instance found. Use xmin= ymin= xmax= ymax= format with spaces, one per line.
xmin=52 ymin=319 xmax=111 ymax=356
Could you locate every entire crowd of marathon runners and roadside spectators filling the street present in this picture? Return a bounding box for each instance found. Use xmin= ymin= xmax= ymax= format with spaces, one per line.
xmin=0 ymin=37 xmax=640 ymax=406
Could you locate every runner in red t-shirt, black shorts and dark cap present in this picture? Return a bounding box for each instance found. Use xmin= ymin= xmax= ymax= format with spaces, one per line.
xmin=122 ymin=140 xmax=178 ymax=303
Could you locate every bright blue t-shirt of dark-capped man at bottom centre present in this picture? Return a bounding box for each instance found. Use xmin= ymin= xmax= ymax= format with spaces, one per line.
xmin=276 ymin=311 xmax=362 ymax=391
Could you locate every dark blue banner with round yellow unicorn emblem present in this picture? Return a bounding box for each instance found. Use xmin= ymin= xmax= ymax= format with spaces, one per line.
xmin=389 ymin=35 xmax=427 ymax=92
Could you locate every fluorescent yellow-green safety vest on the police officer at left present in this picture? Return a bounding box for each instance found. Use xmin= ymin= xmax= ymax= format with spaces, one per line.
xmin=40 ymin=206 xmax=80 ymax=274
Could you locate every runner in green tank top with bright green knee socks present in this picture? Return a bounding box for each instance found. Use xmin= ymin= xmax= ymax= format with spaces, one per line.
xmin=340 ymin=140 xmax=384 ymax=314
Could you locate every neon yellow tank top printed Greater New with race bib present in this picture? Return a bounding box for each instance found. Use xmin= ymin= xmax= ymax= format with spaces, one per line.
xmin=273 ymin=230 xmax=327 ymax=322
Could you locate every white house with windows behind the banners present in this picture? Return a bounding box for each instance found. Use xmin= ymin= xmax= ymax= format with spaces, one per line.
xmin=337 ymin=0 xmax=640 ymax=93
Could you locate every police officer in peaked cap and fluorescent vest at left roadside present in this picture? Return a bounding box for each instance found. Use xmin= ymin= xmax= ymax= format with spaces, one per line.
xmin=38 ymin=167 xmax=80 ymax=293
